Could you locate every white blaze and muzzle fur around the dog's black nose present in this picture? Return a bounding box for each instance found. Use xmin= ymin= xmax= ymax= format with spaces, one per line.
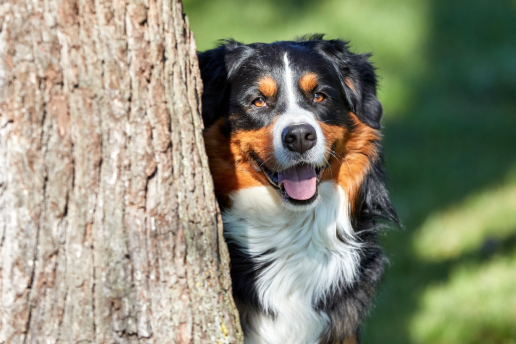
xmin=273 ymin=53 xmax=326 ymax=170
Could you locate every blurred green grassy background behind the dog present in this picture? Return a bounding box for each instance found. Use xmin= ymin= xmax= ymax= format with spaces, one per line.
xmin=184 ymin=0 xmax=516 ymax=344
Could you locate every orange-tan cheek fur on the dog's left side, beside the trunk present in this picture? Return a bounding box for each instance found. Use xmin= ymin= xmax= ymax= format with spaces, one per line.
xmin=204 ymin=118 xmax=274 ymax=205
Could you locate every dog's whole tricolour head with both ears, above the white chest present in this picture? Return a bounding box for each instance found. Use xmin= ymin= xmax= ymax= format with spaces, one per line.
xmin=199 ymin=39 xmax=382 ymax=210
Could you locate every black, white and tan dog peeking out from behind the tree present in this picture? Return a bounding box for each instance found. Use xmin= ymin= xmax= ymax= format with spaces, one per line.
xmin=198 ymin=35 xmax=398 ymax=344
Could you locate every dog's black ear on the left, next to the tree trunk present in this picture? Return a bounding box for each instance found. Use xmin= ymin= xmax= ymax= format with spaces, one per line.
xmin=197 ymin=40 xmax=252 ymax=128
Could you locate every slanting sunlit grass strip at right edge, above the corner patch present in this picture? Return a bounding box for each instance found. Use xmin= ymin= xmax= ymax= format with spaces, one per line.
xmin=413 ymin=171 xmax=516 ymax=260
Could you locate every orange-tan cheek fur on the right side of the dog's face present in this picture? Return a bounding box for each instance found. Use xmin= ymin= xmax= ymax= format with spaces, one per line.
xmin=319 ymin=113 xmax=381 ymax=212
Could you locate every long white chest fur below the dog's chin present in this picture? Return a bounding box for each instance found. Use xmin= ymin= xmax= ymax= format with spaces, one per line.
xmin=223 ymin=182 xmax=361 ymax=344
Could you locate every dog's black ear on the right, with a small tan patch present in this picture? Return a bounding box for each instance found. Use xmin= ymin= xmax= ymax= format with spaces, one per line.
xmin=320 ymin=40 xmax=383 ymax=129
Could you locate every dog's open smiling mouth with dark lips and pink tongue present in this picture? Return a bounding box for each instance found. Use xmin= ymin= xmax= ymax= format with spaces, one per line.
xmin=257 ymin=155 xmax=326 ymax=205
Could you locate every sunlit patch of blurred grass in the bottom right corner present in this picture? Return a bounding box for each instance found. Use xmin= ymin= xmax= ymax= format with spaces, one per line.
xmin=410 ymin=252 xmax=516 ymax=344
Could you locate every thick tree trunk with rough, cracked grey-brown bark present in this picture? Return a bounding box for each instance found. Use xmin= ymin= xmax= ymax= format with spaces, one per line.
xmin=0 ymin=0 xmax=242 ymax=344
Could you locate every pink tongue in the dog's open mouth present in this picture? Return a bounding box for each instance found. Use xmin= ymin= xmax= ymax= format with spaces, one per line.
xmin=278 ymin=165 xmax=317 ymax=201
